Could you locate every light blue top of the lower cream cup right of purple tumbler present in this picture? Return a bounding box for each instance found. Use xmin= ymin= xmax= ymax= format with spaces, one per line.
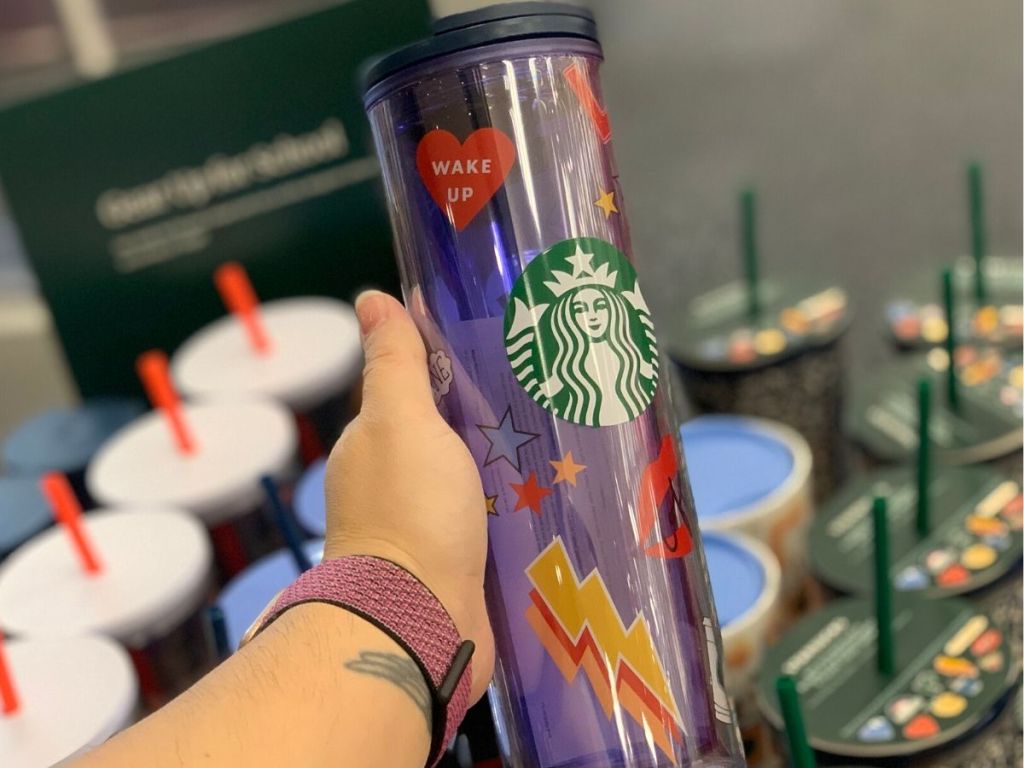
xmin=700 ymin=531 xmax=765 ymax=628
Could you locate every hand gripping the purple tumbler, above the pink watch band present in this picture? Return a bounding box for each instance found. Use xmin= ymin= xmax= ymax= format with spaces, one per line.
xmin=324 ymin=291 xmax=495 ymax=700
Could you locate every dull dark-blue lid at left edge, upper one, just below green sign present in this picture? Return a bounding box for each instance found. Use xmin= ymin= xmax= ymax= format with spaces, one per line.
xmin=3 ymin=398 xmax=145 ymax=474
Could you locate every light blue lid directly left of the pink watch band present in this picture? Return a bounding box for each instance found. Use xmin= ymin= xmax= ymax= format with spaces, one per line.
xmin=217 ymin=539 xmax=324 ymax=651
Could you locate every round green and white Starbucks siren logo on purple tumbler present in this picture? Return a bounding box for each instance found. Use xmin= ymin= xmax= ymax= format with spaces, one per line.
xmin=505 ymin=238 xmax=658 ymax=427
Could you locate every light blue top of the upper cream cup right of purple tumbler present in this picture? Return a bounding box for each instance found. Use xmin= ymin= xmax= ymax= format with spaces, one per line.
xmin=679 ymin=416 xmax=795 ymax=519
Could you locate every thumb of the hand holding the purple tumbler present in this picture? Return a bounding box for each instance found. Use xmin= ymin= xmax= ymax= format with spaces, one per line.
xmin=355 ymin=291 xmax=434 ymax=419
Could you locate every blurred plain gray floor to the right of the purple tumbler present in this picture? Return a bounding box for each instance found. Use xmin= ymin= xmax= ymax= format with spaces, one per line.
xmin=590 ymin=0 xmax=1022 ymax=376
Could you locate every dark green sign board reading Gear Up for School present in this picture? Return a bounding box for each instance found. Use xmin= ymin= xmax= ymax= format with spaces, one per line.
xmin=0 ymin=0 xmax=429 ymax=395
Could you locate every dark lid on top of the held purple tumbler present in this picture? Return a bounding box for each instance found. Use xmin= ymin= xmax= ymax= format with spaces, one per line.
xmin=361 ymin=2 xmax=597 ymax=101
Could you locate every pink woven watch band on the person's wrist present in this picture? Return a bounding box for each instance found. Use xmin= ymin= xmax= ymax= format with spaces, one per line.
xmin=249 ymin=556 xmax=473 ymax=766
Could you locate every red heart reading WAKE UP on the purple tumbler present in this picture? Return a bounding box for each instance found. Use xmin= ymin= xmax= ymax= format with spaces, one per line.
xmin=416 ymin=128 xmax=515 ymax=232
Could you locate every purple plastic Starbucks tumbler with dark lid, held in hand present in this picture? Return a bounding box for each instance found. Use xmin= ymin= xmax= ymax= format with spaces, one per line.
xmin=365 ymin=3 xmax=743 ymax=768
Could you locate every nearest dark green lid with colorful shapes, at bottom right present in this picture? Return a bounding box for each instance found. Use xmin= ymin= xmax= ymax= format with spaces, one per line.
xmin=758 ymin=598 xmax=1020 ymax=759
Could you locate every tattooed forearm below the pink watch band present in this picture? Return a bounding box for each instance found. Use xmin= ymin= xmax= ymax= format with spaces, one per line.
xmin=75 ymin=603 xmax=430 ymax=768
